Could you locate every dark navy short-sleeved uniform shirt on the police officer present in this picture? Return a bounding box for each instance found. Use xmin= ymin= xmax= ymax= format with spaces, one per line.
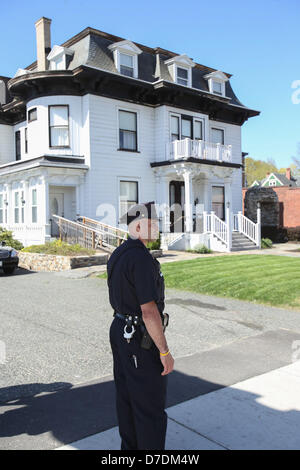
xmin=107 ymin=238 xmax=164 ymax=315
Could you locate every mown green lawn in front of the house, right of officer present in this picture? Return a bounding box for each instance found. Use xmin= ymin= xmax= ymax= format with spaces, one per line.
xmin=99 ymin=255 xmax=300 ymax=310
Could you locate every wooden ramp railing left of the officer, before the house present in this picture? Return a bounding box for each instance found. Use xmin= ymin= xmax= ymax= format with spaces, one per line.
xmin=52 ymin=215 xmax=128 ymax=252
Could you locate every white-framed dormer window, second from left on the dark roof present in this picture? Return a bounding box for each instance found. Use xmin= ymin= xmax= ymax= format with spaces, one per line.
xmin=108 ymin=40 xmax=142 ymax=78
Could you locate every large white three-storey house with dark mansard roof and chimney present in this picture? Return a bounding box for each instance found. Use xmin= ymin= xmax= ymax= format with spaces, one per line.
xmin=0 ymin=17 xmax=259 ymax=250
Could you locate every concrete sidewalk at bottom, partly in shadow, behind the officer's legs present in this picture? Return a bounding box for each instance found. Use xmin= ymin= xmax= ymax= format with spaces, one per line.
xmin=56 ymin=361 xmax=300 ymax=450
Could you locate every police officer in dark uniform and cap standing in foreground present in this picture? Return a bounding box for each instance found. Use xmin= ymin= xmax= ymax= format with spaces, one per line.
xmin=107 ymin=202 xmax=174 ymax=450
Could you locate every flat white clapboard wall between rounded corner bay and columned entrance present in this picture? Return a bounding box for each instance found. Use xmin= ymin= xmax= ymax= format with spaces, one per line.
xmin=84 ymin=95 xmax=155 ymax=225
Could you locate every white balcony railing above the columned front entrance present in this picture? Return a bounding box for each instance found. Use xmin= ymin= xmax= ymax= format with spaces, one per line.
xmin=166 ymin=138 xmax=232 ymax=162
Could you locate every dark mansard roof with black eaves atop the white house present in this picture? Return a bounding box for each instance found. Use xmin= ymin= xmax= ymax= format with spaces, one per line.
xmin=0 ymin=28 xmax=259 ymax=125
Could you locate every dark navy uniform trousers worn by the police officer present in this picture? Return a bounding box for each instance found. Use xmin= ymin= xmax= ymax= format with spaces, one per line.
xmin=109 ymin=317 xmax=167 ymax=450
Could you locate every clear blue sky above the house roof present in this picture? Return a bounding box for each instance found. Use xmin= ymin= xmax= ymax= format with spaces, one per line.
xmin=0 ymin=0 xmax=300 ymax=168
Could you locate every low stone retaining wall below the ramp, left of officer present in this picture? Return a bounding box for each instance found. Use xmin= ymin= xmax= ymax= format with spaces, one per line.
xmin=19 ymin=251 xmax=109 ymax=271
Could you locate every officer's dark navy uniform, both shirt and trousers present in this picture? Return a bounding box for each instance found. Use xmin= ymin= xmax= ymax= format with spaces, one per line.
xmin=107 ymin=203 xmax=167 ymax=450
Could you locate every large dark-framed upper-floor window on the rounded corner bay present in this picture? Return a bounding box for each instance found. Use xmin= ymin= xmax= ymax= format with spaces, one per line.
xmin=49 ymin=105 xmax=70 ymax=148
